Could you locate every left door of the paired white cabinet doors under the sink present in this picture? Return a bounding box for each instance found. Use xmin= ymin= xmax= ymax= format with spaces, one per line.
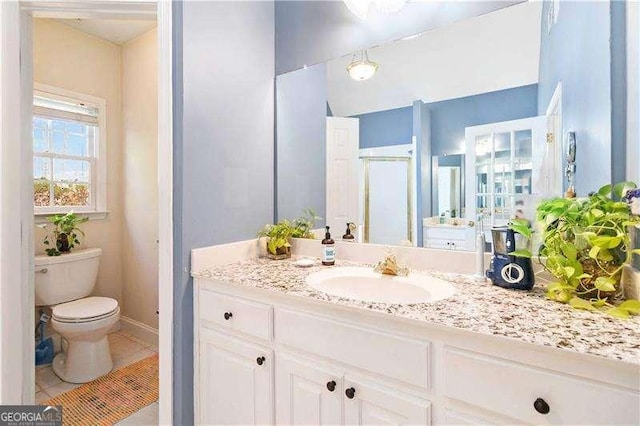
xmin=276 ymin=352 xmax=344 ymax=425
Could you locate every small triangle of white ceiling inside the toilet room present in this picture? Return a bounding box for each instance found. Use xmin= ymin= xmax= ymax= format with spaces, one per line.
xmin=54 ymin=18 xmax=156 ymax=44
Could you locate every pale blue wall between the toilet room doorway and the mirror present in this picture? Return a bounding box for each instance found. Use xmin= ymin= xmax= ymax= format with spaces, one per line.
xmin=173 ymin=1 xmax=275 ymax=425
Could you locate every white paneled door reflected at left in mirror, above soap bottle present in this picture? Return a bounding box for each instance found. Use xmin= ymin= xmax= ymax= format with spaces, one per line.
xmin=326 ymin=117 xmax=360 ymax=239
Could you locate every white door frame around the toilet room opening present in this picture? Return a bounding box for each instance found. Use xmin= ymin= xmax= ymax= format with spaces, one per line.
xmin=0 ymin=0 xmax=173 ymax=424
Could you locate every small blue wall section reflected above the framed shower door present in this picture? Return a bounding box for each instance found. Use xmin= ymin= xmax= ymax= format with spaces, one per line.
xmin=354 ymin=106 xmax=413 ymax=148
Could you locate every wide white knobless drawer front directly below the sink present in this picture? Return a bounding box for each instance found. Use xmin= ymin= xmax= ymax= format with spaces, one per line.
xmin=274 ymin=308 xmax=431 ymax=389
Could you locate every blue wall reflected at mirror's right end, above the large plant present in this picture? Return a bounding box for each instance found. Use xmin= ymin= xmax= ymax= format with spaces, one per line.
xmin=538 ymin=1 xmax=612 ymax=195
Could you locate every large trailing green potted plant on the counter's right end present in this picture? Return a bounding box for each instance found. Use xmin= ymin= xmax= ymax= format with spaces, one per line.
xmin=511 ymin=182 xmax=640 ymax=317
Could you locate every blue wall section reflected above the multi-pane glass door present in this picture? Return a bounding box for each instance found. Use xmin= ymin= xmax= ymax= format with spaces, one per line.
xmin=427 ymin=84 xmax=538 ymax=155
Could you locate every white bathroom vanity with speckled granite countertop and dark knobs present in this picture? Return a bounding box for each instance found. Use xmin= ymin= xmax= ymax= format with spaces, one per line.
xmin=192 ymin=242 xmax=640 ymax=425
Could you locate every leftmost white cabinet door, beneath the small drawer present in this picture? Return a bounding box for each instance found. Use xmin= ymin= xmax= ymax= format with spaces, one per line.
xmin=196 ymin=328 xmax=273 ymax=425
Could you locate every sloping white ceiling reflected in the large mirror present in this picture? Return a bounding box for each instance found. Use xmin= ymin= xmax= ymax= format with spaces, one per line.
xmin=327 ymin=2 xmax=542 ymax=117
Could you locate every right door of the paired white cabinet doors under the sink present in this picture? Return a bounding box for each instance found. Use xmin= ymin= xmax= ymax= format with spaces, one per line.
xmin=343 ymin=377 xmax=431 ymax=425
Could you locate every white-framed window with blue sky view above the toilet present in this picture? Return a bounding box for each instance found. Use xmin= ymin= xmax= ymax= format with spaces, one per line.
xmin=33 ymin=85 xmax=106 ymax=214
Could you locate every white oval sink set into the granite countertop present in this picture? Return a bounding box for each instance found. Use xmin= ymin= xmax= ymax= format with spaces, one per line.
xmin=306 ymin=266 xmax=455 ymax=304
